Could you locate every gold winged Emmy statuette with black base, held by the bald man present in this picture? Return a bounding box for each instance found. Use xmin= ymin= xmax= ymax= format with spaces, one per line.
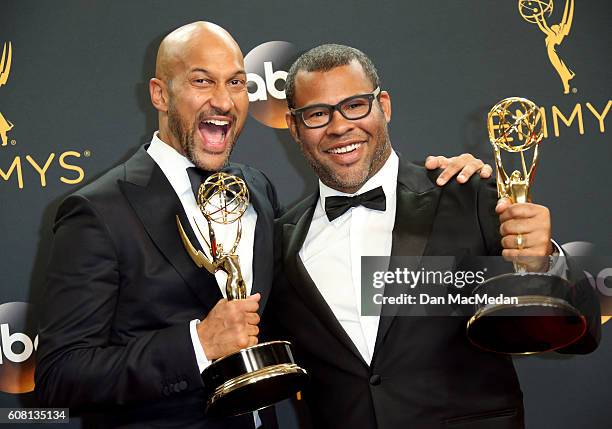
xmin=176 ymin=173 xmax=308 ymax=416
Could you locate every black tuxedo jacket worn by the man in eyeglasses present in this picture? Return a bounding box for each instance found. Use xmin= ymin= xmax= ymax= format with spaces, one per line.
xmin=265 ymin=160 xmax=596 ymax=429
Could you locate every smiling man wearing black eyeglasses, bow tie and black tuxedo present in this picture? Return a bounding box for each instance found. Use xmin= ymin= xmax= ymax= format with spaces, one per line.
xmin=265 ymin=45 xmax=596 ymax=429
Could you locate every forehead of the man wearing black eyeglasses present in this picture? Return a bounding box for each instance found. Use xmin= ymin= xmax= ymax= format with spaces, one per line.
xmin=294 ymin=61 xmax=374 ymax=107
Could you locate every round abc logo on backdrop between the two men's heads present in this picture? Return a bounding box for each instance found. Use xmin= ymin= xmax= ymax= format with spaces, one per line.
xmin=244 ymin=41 xmax=298 ymax=128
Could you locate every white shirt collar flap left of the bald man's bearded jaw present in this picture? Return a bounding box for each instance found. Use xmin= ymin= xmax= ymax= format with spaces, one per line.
xmin=147 ymin=131 xmax=194 ymax=195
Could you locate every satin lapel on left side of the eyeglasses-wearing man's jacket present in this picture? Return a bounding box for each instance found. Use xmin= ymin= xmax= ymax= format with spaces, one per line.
xmin=283 ymin=194 xmax=368 ymax=366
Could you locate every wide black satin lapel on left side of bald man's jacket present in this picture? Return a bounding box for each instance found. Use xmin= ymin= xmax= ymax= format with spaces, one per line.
xmin=119 ymin=149 xmax=222 ymax=313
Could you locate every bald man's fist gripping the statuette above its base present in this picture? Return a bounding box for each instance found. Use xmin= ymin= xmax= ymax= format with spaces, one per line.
xmin=197 ymin=293 xmax=261 ymax=360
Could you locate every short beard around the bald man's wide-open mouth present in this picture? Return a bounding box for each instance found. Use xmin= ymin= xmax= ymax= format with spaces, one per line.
xmin=168 ymin=98 xmax=238 ymax=171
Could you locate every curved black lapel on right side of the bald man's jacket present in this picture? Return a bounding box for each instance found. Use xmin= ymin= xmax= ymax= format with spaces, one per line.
xmin=230 ymin=165 xmax=274 ymax=314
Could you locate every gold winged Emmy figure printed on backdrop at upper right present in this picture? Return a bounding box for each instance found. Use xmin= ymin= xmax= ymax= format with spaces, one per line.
xmin=518 ymin=0 xmax=575 ymax=94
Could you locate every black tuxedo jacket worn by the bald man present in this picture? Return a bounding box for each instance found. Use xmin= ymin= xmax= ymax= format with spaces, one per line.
xmin=35 ymin=147 xmax=278 ymax=428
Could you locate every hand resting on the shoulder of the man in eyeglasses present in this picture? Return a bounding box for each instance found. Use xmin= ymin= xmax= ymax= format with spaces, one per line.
xmin=425 ymin=153 xmax=493 ymax=186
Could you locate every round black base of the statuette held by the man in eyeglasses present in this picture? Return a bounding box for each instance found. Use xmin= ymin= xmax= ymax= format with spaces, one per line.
xmin=467 ymin=273 xmax=586 ymax=355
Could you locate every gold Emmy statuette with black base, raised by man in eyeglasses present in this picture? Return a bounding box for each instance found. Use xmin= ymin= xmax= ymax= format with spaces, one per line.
xmin=467 ymin=97 xmax=586 ymax=354
